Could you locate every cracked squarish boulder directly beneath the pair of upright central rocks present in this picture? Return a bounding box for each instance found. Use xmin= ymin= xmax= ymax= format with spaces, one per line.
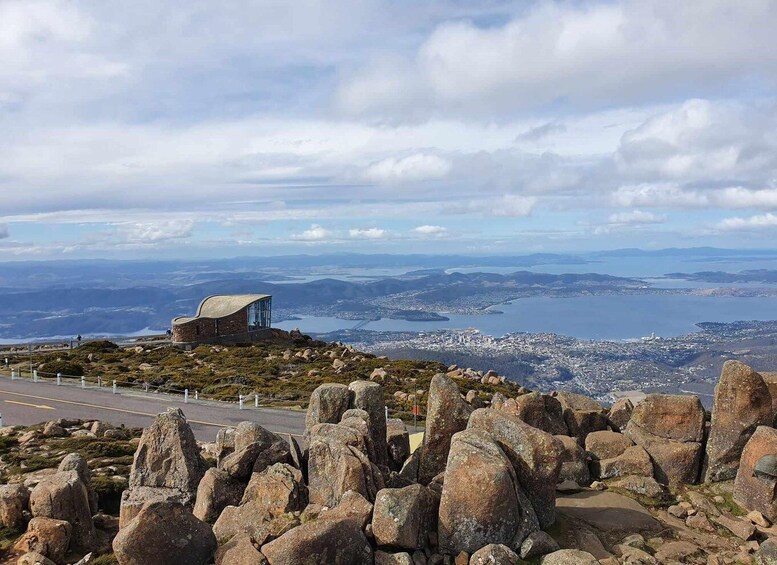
xmin=308 ymin=424 xmax=382 ymax=508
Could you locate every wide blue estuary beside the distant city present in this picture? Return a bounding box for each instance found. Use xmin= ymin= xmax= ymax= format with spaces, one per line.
xmin=274 ymin=294 xmax=777 ymax=340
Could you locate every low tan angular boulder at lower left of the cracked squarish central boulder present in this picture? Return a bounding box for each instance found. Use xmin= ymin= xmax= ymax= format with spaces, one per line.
xmin=241 ymin=463 xmax=308 ymax=516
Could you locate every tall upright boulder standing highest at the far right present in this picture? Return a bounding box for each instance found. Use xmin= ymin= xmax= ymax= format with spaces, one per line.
xmin=704 ymin=361 xmax=773 ymax=481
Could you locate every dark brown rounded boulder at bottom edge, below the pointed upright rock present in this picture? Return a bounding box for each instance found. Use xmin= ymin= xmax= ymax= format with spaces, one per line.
xmin=113 ymin=502 xmax=217 ymax=565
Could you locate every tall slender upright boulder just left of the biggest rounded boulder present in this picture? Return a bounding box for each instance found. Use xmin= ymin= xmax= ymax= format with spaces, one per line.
xmin=418 ymin=373 xmax=472 ymax=484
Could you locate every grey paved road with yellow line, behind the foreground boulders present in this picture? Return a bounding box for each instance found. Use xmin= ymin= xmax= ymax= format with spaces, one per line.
xmin=0 ymin=376 xmax=305 ymax=441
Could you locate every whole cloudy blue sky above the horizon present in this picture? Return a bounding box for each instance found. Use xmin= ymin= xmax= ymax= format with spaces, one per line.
xmin=0 ymin=0 xmax=777 ymax=261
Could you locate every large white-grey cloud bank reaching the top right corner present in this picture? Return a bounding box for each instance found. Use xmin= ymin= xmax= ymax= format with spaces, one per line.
xmin=338 ymin=0 xmax=777 ymax=116
